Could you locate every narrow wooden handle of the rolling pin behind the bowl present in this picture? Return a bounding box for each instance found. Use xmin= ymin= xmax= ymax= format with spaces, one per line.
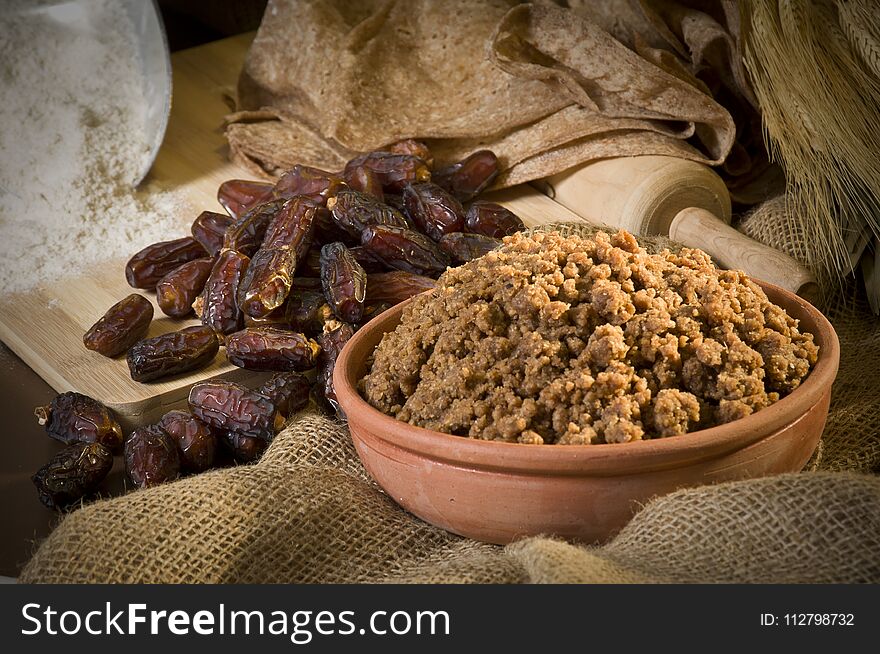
xmin=669 ymin=207 xmax=819 ymax=303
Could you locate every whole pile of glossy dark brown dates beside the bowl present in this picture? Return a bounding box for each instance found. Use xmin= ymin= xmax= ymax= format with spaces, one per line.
xmin=33 ymin=140 xmax=524 ymax=507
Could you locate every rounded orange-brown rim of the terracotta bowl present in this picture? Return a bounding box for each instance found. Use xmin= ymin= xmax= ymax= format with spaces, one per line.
xmin=333 ymin=280 xmax=840 ymax=476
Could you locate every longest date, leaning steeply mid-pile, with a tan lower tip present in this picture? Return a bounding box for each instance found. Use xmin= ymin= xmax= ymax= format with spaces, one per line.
xmin=238 ymin=196 xmax=318 ymax=318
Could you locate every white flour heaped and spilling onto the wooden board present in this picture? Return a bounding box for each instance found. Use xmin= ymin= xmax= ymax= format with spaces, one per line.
xmin=0 ymin=0 xmax=186 ymax=295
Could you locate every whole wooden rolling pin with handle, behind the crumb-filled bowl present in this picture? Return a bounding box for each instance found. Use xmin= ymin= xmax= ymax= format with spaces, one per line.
xmin=537 ymin=156 xmax=818 ymax=302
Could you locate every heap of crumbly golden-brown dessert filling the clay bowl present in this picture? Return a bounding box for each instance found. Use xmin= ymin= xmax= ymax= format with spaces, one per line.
xmin=362 ymin=231 xmax=818 ymax=444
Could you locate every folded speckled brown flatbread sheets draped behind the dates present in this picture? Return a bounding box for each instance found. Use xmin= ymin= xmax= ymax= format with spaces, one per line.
xmin=227 ymin=0 xmax=779 ymax=203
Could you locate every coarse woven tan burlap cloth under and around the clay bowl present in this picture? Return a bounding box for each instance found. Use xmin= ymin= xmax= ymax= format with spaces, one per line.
xmin=21 ymin=204 xmax=880 ymax=583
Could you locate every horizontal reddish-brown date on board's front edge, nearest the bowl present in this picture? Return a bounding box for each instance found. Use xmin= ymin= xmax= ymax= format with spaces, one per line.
xmin=226 ymin=327 xmax=320 ymax=372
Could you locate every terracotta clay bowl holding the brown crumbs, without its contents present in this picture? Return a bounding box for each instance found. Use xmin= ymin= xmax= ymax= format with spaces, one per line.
xmin=333 ymin=283 xmax=840 ymax=543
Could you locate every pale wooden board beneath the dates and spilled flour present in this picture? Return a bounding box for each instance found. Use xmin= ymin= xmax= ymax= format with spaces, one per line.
xmin=0 ymin=34 xmax=582 ymax=429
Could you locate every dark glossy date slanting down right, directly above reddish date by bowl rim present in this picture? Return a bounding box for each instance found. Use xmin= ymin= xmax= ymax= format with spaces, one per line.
xmin=361 ymin=225 xmax=449 ymax=277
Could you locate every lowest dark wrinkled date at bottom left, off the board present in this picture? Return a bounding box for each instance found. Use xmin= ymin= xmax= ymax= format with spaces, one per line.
xmin=31 ymin=443 xmax=113 ymax=509
